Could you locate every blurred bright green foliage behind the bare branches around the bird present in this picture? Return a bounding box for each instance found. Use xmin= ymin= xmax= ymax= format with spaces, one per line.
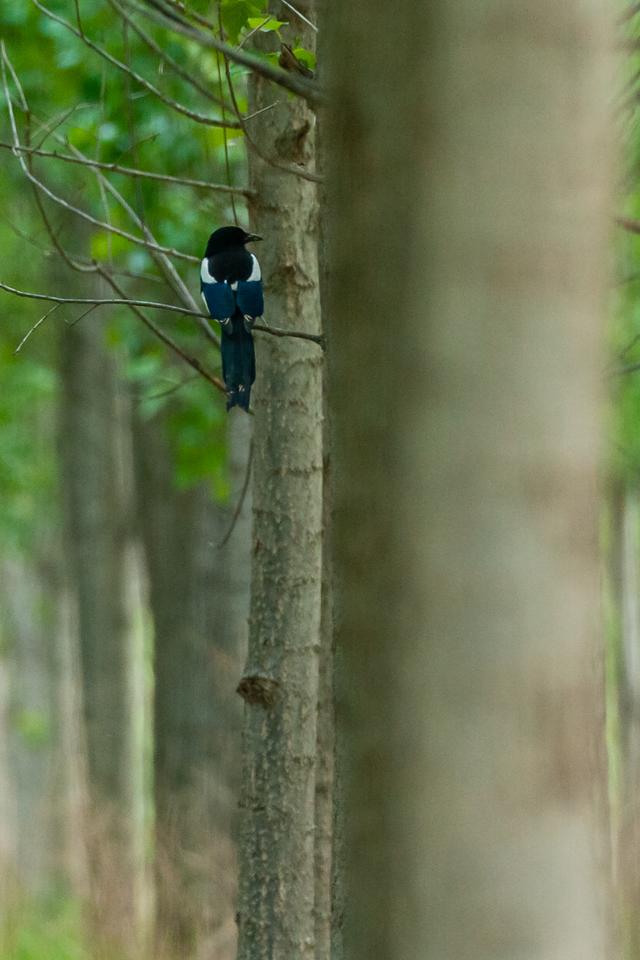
xmin=0 ymin=0 xmax=284 ymax=548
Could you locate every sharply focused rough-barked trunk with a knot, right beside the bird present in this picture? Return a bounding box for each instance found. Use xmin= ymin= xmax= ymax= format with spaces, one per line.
xmin=239 ymin=2 xmax=323 ymax=960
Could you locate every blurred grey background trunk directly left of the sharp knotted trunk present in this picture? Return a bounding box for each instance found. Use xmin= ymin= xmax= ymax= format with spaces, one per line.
xmin=135 ymin=411 xmax=248 ymax=957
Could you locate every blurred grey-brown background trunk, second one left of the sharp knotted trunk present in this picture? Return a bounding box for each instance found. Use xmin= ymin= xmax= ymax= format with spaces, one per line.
xmin=60 ymin=318 xmax=142 ymax=951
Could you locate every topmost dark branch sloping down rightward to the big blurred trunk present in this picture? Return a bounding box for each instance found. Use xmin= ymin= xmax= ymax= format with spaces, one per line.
xmin=125 ymin=0 xmax=325 ymax=106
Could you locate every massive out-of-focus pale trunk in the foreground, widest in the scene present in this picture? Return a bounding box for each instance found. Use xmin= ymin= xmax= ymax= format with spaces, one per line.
xmin=326 ymin=0 xmax=612 ymax=960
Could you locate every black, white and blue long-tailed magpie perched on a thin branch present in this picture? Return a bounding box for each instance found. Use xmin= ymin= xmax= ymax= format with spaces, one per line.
xmin=200 ymin=227 xmax=264 ymax=410
